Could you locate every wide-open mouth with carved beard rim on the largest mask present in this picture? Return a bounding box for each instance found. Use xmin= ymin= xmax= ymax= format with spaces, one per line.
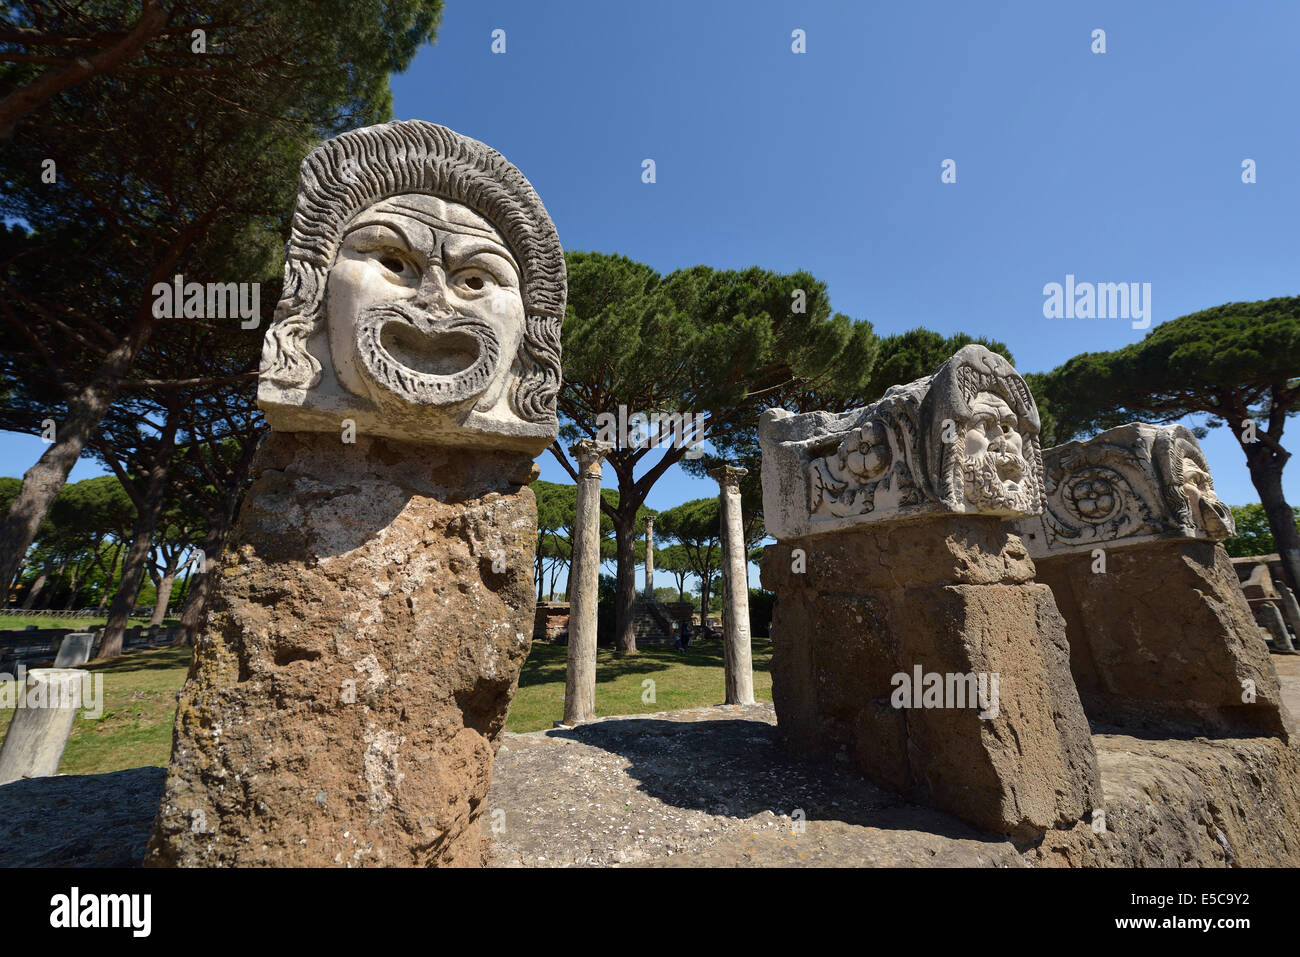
xmin=356 ymin=304 xmax=501 ymax=406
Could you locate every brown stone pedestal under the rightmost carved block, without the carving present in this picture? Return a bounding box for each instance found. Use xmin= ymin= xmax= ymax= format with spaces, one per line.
xmin=1035 ymin=540 xmax=1290 ymax=735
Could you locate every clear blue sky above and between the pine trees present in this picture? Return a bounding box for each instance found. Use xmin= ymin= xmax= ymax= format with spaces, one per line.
xmin=0 ymin=0 xmax=1300 ymax=595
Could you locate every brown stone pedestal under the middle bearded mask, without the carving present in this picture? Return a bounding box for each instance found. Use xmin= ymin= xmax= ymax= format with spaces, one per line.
xmin=763 ymin=515 xmax=1100 ymax=837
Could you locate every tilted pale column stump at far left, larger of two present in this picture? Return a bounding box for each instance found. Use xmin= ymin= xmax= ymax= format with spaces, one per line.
xmin=0 ymin=668 xmax=90 ymax=784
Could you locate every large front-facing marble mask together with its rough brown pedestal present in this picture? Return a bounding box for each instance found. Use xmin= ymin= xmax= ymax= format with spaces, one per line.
xmin=146 ymin=121 xmax=566 ymax=867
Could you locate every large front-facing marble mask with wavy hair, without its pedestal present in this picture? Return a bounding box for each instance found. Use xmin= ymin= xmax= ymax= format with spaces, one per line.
xmin=257 ymin=121 xmax=566 ymax=455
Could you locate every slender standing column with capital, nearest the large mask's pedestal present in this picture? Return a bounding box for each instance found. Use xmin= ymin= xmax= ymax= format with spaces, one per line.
xmin=564 ymin=438 xmax=612 ymax=724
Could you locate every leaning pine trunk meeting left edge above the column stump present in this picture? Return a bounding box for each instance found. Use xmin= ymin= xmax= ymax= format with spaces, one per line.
xmin=0 ymin=321 xmax=150 ymax=600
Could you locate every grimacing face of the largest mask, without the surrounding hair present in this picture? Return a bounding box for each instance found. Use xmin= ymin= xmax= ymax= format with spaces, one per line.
xmin=326 ymin=194 xmax=524 ymax=412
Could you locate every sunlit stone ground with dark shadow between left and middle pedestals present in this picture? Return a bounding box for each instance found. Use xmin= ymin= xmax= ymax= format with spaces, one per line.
xmin=484 ymin=705 xmax=1023 ymax=867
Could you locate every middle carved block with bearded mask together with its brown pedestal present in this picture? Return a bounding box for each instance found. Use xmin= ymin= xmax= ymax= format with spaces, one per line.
xmin=759 ymin=345 xmax=1101 ymax=839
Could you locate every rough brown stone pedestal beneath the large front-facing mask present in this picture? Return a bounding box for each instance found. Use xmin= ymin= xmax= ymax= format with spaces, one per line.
xmin=147 ymin=433 xmax=537 ymax=866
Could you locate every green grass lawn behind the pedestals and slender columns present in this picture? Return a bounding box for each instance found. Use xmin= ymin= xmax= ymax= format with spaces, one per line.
xmin=0 ymin=638 xmax=772 ymax=774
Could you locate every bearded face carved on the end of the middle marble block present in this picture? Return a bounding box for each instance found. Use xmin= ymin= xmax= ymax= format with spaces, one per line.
xmin=958 ymin=393 xmax=1032 ymax=512
